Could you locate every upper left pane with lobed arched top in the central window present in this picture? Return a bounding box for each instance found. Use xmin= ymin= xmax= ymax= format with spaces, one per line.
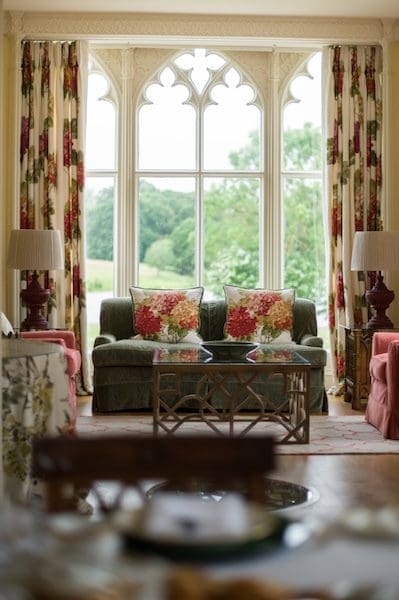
xmin=138 ymin=67 xmax=196 ymax=170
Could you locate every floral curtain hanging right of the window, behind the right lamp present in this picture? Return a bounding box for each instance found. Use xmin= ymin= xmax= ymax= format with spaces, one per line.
xmin=326 ymin=46 xmax=382 ymax=393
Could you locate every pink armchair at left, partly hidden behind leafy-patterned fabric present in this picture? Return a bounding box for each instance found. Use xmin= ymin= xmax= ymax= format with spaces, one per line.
xmin=20 ymin=329 xmax=81 ymax=429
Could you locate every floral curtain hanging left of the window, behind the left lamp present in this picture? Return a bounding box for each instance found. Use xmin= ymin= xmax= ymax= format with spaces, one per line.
xmin=20 ymin=41 xmax=89 ymax=388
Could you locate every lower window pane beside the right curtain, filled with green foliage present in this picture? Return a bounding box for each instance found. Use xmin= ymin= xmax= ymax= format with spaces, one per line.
xmin=283 ymin=177 xmax=326 ymax=312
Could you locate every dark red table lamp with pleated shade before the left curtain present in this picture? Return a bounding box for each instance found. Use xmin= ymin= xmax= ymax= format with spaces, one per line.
xmin=7 ymin=229 xmax=64 ymax=330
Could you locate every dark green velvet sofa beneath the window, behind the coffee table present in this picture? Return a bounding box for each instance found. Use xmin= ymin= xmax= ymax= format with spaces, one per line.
xmin=92 ymin=297 xmax=327 ymax=413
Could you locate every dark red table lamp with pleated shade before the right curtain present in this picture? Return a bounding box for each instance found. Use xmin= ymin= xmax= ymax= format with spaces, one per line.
xmin=351 ymin=231 xmax=399 ymax=329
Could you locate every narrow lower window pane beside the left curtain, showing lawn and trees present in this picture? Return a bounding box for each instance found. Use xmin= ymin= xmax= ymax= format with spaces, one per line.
xmin=85 ymin=177 xmax=115 ymax=348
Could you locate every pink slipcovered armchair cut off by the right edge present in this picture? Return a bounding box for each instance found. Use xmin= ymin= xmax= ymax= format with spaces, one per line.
xmin=365 ymin=331 xmax=399 ymax=440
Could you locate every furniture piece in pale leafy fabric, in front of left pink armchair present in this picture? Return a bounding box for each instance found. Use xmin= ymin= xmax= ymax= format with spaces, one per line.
xmin=2 ymin=338 xmax=73 ymax=503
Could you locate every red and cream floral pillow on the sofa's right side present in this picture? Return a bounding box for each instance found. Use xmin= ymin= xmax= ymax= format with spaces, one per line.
xmin=224 ymin=285 xmax=295 ymax=344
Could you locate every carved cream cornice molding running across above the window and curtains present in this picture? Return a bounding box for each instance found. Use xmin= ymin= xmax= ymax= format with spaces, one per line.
xmin=5 ymin=11 xmax=399 ymax=45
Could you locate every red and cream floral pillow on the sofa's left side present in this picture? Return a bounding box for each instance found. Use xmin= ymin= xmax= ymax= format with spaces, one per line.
xmin=130 ymin=287 xmax=204 ymax=343
